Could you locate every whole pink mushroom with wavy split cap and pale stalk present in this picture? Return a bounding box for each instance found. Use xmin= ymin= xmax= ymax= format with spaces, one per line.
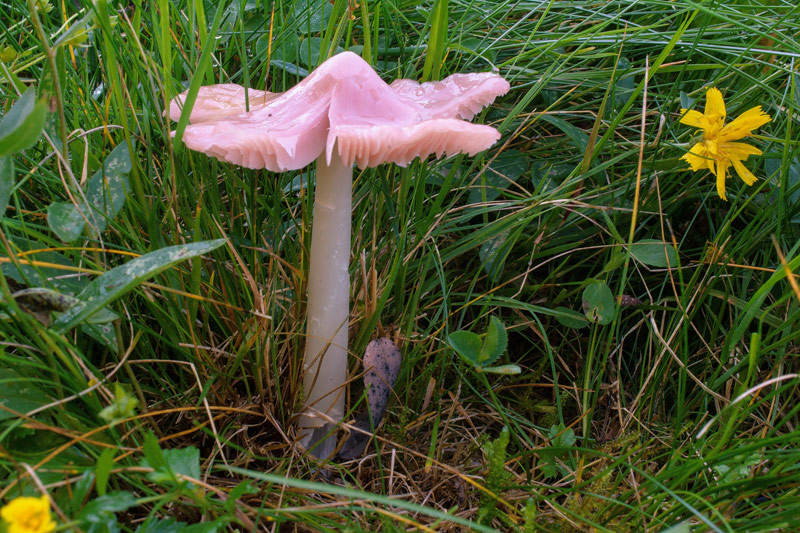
xmin=170 ymin=52 xmax=509 ymax=457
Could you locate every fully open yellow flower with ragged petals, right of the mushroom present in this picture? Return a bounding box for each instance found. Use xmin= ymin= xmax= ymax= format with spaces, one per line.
xmin=681 ymin=88 xmax=772 ymax=201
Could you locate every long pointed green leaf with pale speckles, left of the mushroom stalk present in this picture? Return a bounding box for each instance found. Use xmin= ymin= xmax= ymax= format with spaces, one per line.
xmin=53 ymin=239 xmax=225 ymax=333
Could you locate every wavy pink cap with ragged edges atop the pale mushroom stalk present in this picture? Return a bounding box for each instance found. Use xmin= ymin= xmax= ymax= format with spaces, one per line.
xmin=169 ymin=52 xmax=509 ymax=172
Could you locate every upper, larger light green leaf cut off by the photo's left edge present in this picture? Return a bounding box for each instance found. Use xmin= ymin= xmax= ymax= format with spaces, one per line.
xmin=0 ymin=87 xmax=47 ymax=157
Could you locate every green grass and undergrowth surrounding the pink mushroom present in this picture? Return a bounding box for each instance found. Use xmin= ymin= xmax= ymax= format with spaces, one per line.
xmin=0 ymin=0 xmax=800 ymax=532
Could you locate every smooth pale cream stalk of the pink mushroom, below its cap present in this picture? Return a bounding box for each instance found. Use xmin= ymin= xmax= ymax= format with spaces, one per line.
xmin=299 ymin=149 xmax=353 ymax=458
